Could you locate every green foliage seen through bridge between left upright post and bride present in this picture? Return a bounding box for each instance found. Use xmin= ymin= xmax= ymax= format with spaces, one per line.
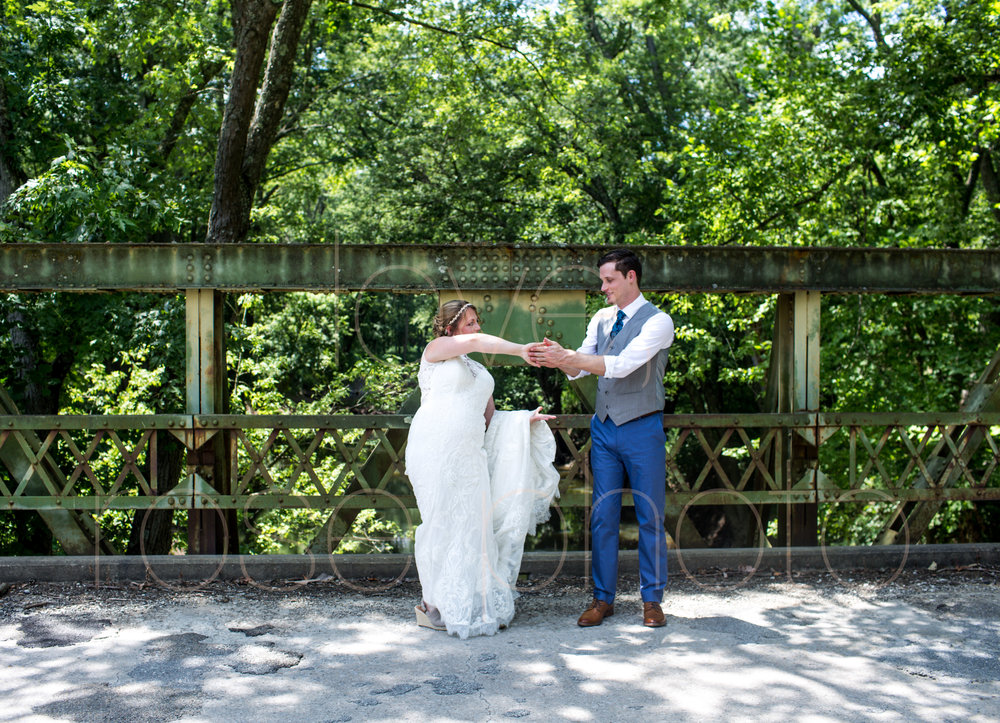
xmin=228 ymin=293 xmax=432 ymax=553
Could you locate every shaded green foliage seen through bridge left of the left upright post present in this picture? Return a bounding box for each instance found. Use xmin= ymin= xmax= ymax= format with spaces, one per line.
xmin=0 ymin=294 xmax=184 ymax=554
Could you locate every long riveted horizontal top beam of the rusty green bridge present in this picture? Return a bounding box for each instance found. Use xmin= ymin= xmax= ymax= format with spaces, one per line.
xmin=0 ymin=243 xmax=1000 ymax=294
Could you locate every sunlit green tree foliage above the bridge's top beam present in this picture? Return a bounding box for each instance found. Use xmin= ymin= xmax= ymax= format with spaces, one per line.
xmin=0 ymin=0 xmax=1000 ymax=247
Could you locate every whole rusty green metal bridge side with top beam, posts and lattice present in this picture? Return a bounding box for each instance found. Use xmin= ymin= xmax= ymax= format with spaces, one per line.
xmin=0 ymin=243 xmax=1000 ymax=554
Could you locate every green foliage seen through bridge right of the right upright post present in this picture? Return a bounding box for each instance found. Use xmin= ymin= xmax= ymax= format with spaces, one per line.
xmin=820 ymin=296 xmax=1000 ymax=544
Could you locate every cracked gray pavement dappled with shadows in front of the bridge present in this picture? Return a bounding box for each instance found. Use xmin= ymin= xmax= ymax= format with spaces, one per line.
xmin=0 ymin=565 xmax=1000 ymax=722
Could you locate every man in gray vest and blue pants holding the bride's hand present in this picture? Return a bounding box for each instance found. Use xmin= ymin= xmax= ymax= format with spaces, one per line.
xmin=529 ymin=249 xmax=674 ymax=628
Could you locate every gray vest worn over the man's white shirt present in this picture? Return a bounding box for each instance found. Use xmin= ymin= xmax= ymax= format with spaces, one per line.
xmin=594 ymin=302 xmax=667 ymax=425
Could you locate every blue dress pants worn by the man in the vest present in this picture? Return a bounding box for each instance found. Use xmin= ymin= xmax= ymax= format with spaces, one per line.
xmin=590 ymin=414 xmax=667 ymax=603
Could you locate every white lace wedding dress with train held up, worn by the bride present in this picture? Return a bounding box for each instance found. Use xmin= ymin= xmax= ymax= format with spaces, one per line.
xmin=406 ymin=356 xmax=559 ymax=638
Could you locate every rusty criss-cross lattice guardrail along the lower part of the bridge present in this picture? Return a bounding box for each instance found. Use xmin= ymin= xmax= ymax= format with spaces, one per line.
xmin=0 ymin=413 xmax=1000 ymax=552
